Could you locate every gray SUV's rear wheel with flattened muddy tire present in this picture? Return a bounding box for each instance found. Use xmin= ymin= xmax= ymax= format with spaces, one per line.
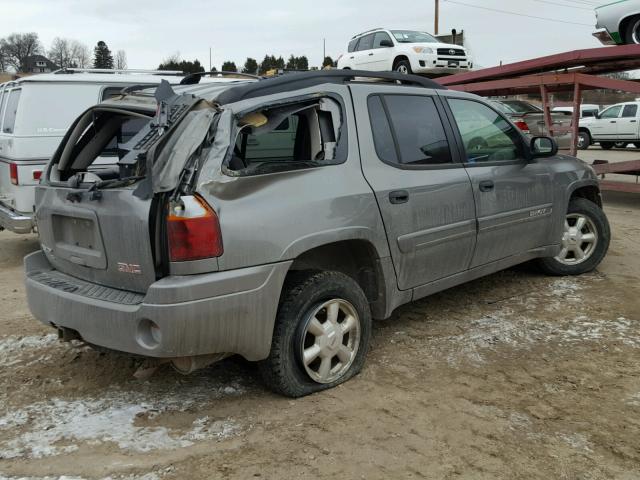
xmin=259 ymin=272 xmax=371 ymax=397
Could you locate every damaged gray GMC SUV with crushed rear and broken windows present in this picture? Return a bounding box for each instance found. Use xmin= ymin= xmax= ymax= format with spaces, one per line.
xmin=25 ymin=71 xmax=610 ymax=397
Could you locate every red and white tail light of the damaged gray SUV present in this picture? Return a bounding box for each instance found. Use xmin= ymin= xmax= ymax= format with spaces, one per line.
xmin=167 ymin=195 xmax=223 ymax=262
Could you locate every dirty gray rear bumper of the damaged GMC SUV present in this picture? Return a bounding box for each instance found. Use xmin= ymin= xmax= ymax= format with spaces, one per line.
xmin=25 ymin=251 xmax=291 ymax=361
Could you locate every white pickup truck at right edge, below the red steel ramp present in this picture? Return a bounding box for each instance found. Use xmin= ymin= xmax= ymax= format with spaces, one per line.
xmin=578 ymin=102 xmax=640 ymax=150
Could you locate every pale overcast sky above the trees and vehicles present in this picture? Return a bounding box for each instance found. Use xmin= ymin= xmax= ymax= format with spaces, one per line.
xmin=0 ymin=0 xmax=606 ymax=69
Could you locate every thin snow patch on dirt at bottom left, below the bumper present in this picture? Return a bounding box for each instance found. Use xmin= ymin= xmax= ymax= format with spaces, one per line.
xmin=0 ymin=382 xmax=244 ymax=458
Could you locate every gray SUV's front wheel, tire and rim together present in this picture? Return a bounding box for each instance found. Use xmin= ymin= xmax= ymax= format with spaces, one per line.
xmin=539 ymin=198 xmax=611 ymax=275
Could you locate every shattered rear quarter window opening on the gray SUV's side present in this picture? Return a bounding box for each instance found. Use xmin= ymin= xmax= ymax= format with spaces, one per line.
xmin=227 ymin=97 xmax=346 ymax=175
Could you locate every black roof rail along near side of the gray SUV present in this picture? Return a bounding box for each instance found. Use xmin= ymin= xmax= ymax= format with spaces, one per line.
xmin=216 ymin=70 xmax=446 ymax=104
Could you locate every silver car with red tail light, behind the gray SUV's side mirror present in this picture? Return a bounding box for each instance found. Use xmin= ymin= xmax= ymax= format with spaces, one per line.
xmin=491 ymin=100 xmax=571 ymax=149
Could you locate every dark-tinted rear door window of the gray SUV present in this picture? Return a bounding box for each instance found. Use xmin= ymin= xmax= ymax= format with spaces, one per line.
xmin=369 ymin=95 xmax=452 ymax=166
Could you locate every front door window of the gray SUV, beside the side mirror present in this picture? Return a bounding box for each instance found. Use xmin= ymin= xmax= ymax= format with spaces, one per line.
xmin=449 ymin=99 xmax=523 ymax=163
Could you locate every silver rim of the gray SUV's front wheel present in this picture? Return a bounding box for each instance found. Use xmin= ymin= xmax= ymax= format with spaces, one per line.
xmin=556 ymin=213 xmax=598 ymax=265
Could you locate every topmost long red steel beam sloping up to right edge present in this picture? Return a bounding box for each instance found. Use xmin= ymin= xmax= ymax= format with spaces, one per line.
xmin=437 ymin=45 xmax=640 ymax=86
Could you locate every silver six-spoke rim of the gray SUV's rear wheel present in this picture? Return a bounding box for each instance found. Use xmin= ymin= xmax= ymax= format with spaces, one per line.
xmin=300 ymin=298 xmax=361 ymax=383
